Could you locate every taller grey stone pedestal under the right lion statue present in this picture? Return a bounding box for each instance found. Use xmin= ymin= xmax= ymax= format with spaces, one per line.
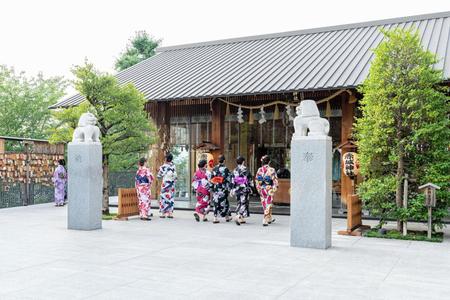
xmin=290 ymin=136 xmax=331 ymax=249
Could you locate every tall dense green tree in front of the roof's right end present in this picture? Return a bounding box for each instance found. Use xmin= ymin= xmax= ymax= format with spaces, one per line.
xmin=355 ymin=29 xmax=450 ymax=230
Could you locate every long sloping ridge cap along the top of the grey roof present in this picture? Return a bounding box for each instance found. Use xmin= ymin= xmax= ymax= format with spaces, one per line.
xmin=156 ymin=11 xmax=450 ymax=52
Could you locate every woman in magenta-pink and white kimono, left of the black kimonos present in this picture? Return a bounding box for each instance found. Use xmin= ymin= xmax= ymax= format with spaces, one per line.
xmin=192 ymin=159 xmax=211 ymax=222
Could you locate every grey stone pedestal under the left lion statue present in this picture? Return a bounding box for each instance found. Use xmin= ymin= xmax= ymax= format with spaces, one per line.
xmin=67 ymin=143 xmax=103 ymax=230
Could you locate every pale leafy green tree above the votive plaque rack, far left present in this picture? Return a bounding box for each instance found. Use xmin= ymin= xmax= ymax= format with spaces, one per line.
xmin=0 ymin=65 xmax=66 ymax=138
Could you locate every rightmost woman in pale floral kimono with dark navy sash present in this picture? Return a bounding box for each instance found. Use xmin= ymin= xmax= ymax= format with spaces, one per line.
xmin=255 ymin=155 xmax=278 ymax=226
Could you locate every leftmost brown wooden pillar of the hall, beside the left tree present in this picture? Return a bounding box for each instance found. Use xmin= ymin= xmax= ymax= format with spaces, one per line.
xmin=148 ymin=101 xmax=170 ymax=199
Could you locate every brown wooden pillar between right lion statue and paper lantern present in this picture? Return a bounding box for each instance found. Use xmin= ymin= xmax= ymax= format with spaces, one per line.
xmin=341 ymin=93 xmax=355 ymax=203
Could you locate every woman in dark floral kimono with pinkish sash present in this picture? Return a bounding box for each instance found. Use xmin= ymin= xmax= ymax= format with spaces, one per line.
xmin=231 ymin=156 xmax=254 ymax=225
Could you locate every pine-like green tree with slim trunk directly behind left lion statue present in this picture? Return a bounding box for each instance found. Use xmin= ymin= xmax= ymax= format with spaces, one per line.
xmin=52 ymin=62 xmax=155 ymax=214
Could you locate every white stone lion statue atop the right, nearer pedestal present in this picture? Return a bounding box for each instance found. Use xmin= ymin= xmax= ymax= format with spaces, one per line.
xmin=292 ymin=100 xmax=330 ymax=139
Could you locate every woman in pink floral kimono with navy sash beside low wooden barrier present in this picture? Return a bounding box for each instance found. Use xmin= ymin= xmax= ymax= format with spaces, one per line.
xmin=135 ymin=158 xmax=154 ymax=221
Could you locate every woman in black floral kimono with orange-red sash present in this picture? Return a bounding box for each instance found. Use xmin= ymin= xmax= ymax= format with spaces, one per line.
xmin=211 ymin=155 xmax=231 ymax=224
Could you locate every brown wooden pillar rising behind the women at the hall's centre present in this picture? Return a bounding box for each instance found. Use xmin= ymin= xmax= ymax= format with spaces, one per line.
xmin=211 ymin=100 xmax=225 ymax=163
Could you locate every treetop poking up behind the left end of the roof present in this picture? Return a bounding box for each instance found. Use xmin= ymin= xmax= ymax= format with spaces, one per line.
xmin=115 ymin=31 xmax=161 ymax=71
